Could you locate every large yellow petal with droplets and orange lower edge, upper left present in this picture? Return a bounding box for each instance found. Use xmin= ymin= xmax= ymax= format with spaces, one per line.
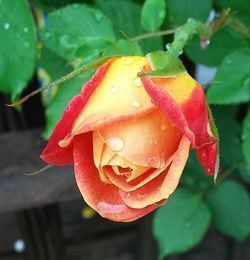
xmin=60 ymin=56 xmax=155 ymax=146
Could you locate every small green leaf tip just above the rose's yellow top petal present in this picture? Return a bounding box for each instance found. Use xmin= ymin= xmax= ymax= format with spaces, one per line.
xmin=103 ymin=39 xmax=143 ymax=56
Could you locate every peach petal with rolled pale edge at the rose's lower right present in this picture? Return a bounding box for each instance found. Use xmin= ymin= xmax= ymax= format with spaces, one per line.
xmin=120 ymin=136 xmax=190 ymax=208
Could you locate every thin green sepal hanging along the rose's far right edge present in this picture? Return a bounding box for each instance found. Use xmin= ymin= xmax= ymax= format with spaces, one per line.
xmin=207 ymin=105 xmax=220 ymax=183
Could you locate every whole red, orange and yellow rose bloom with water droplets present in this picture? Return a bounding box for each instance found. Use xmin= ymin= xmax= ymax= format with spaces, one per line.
xmin=41 ymin=56 xmax=216 ymax=222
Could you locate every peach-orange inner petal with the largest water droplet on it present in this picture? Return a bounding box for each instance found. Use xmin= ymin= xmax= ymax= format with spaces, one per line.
xmin=98 ymin=109 xmax=181 ymax=168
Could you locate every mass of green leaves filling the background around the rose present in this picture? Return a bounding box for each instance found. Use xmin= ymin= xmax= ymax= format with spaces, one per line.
xmin=0 ymin=0 xmax=250 ymax=256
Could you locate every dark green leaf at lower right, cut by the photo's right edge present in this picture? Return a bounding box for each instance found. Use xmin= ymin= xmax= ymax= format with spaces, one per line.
xmin=208 ymin=181 xmax=250 ymax=240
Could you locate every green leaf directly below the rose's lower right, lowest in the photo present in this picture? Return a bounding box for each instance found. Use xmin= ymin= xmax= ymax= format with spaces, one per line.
xmin=153 ymin=188 xmax=210 ymax=256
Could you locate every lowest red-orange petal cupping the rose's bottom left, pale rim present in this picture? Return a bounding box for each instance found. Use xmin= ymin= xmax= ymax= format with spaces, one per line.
xmin=73 ymin=133 xmax=158 ymax=222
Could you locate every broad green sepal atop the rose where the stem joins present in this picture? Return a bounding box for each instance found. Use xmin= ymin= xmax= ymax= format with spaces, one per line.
xmin=138 ymin=51 xmax=186 ymax=78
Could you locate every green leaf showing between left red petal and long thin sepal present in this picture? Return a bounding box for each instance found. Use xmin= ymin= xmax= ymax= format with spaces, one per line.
xmin=43 ymin=73 xmax=90 ymax=139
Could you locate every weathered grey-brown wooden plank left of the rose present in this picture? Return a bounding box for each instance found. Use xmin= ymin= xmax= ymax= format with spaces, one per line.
xmin=0 ymin=130 xmax=81 ymax=213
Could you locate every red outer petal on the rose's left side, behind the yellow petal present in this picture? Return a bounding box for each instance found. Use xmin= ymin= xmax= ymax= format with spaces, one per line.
xmin=41 ymin=60 xmax=111 ymax=165
